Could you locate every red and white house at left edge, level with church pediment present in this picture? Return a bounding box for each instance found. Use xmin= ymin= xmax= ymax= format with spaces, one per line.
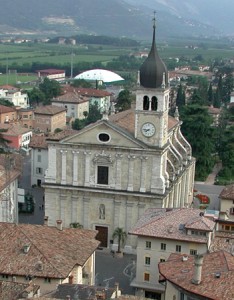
xmin=0 ymin=123 xmax=32 ymax=151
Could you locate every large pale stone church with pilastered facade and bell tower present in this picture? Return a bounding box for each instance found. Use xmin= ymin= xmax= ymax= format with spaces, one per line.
xmin=44 ymin=21 xmax=195 ymax=249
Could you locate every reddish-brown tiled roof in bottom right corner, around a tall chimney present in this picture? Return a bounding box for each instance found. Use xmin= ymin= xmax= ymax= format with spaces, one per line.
xmin=159 ymin=251 xmax=234 ymax=300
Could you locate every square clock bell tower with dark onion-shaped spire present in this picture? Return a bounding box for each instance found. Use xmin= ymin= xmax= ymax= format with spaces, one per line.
xmin=135 ymin=16 xmax=170 ymax=148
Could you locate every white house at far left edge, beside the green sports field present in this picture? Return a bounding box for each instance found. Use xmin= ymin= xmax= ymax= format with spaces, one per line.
xmin=0 ymin=85 xmax=29 ymax=108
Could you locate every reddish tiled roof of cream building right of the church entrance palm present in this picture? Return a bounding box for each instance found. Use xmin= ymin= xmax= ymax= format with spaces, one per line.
xmin=129 ymin=208 xmax=215 ymax=243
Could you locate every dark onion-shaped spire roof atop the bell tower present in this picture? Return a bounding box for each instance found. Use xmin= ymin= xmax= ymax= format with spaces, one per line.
xmin=140 ymin=19 xmax=168 ymax=88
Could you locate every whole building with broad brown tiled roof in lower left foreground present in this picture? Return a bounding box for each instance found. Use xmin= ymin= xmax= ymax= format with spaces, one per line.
xmin=0 ymin=220 xmax=99 ymax=294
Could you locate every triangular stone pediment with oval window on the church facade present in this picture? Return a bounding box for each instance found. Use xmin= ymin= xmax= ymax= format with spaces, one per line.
xmin=60 ymin=121 xmax=146 ymax=148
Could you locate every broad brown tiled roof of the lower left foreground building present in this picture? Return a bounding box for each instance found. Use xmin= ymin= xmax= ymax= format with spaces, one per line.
xmin=0 ymin=223 xmax=100 ymax=278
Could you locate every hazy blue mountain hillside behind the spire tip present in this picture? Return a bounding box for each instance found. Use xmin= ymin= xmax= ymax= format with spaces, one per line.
xmin=0 ymin=0 xmax=228 ymax=39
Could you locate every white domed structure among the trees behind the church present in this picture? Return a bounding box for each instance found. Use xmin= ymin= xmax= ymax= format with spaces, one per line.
xmin=75 ymin=69 xmax=124 ymax=83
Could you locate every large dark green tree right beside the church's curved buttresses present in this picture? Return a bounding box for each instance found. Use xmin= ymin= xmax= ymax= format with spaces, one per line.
xmin=180 ymin=104 xmax=214 ymax=180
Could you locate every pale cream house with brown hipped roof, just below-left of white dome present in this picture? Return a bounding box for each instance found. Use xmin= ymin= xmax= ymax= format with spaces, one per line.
xmin=51 ymin=87 xmax=89 ymax=120
